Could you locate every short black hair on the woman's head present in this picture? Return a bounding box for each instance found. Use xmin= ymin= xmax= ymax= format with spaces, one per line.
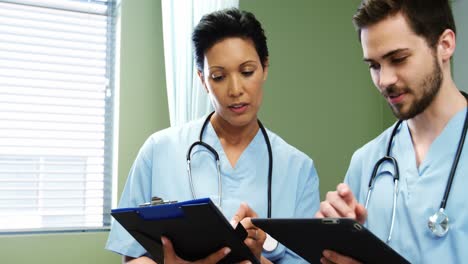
xmin=192 ymin=8 xmax=268 ymax=71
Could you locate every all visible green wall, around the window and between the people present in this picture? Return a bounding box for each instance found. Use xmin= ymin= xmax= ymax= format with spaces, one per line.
xmin=0 ymin=0 xmax=392 ymax=264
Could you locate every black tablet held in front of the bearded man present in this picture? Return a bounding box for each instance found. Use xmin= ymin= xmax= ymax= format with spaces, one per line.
xmin=252 ymin=218 xmax=410 ymax=264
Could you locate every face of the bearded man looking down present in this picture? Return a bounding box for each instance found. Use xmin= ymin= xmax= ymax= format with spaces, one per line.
xmin=361 ymin=14 xmax=443 ymax=120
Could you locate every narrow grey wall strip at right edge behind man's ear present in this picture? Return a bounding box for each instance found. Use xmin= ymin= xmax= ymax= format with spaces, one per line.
xmin=453 ymin=0 xmax=468 ymax=92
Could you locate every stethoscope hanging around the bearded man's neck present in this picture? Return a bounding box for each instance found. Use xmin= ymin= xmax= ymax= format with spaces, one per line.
xmin=365 ymin=92 xmax=468 ymax=243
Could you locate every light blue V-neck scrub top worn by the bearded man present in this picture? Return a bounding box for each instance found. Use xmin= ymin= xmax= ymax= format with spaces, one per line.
xmin=345 ymin=106 xmax=468 ymax=263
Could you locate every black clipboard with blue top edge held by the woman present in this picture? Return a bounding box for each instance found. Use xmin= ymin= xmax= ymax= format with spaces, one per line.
xmin=111 ymin=198 xmax=260 ymax=264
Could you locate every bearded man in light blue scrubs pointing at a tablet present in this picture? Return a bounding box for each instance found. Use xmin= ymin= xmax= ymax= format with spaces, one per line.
xmin=317 ymin=0 xmax=468 ymax=263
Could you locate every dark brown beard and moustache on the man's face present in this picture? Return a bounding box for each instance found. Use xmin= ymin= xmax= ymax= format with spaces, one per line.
xmin=386 ymin=56 xmax=444 ymax=120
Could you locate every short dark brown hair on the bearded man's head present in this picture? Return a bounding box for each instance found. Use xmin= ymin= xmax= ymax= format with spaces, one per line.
xmin=353 ymin=0 xmax=456 ymax=48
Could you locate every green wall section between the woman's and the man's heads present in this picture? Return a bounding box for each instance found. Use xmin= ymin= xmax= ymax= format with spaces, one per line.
xmin=240 ymin=0 xmax=394 ymax=197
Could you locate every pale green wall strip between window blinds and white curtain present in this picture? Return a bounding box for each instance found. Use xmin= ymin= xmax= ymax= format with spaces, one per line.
xmin=118 ymin=0 xmax=170 ymax=200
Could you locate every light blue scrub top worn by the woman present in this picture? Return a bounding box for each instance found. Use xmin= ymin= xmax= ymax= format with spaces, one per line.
xmin=106 ymin=117 xmax=320 ymax=263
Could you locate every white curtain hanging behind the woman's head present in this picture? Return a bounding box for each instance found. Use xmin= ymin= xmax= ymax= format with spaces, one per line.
xmin=161 ymin=0 xmax=239 ymax=126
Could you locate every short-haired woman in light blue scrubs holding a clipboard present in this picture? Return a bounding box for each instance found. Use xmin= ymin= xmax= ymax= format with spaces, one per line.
xmin=106 ymin=9 xmax=319 ymax=263
